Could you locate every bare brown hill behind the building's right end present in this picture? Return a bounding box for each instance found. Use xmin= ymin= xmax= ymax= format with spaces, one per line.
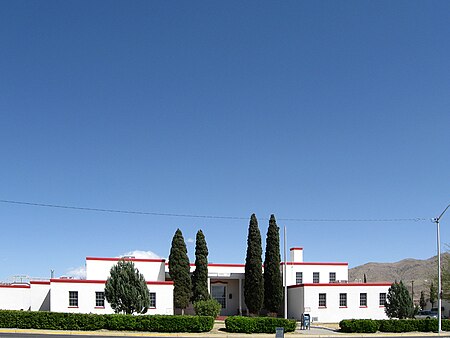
xmin=348 ymin=253 xmax=450 ymax=301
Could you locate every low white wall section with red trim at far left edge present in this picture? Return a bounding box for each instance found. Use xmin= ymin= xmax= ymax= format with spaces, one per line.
xmin=0 ymin=284 xmax=30 ymax=311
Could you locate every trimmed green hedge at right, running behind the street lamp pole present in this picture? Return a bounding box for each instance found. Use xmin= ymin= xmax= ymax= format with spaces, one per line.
xmin=339 ymin=319 xmax=450 ymax=333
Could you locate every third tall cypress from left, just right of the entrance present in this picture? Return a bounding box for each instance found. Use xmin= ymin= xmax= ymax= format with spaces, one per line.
xmin=244 ymin=214 xmax=264 ymax=315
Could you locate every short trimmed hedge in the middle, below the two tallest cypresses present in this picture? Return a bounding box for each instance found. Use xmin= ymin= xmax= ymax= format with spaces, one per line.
xmin=225 ymin=316 xmax=297 ymax=333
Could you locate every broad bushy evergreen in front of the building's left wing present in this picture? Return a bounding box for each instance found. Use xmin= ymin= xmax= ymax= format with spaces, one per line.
xmin=105 ymin=260 xmax=150 ymax=314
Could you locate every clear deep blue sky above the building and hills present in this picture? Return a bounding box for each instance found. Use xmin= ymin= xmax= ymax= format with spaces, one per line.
xmin=0 ymin=0 xmax=450 ymax=280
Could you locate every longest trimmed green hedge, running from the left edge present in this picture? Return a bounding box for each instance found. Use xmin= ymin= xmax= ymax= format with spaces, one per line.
xmin=0 ymin=310 xmax=214 ymax=332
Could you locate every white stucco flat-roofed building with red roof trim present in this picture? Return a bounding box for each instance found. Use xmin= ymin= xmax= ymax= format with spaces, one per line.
xmin=0 ymin=248 xmax=391 ymax=322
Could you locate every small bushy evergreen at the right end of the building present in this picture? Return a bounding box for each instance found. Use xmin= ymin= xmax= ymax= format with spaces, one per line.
xmin=384 ymin=281 xmax=414 ymax=319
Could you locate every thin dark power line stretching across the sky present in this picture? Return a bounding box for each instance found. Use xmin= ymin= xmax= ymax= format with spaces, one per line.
xmin=0 ymin=200 xmax=429 ymax=222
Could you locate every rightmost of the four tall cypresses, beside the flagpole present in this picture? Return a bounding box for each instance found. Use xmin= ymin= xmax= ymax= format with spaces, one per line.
xmin=264 ymin=215 xmax=283 ymax=314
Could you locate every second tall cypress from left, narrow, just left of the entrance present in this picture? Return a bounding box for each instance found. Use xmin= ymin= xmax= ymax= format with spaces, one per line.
xmin=192 ymin=230 xmax=210 ymax=302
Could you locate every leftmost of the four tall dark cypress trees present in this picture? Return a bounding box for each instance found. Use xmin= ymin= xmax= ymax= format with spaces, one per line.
xmin=169 ymin=229 xmax=191 ymax=314
